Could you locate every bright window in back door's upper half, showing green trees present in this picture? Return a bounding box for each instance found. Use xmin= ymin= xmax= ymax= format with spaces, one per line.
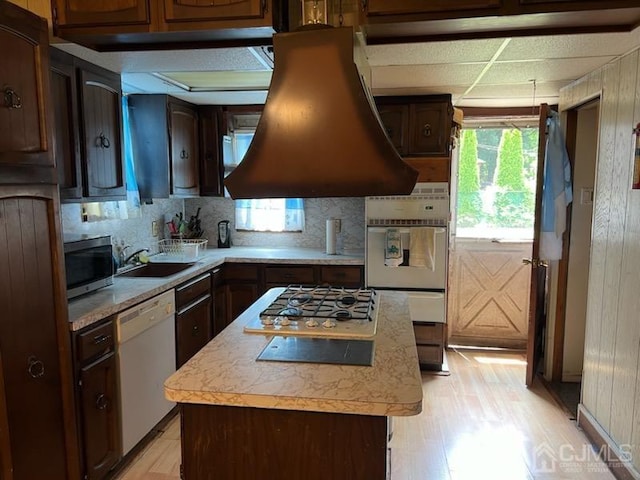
xmin=456 ymin=119 xmax=538 ymax=240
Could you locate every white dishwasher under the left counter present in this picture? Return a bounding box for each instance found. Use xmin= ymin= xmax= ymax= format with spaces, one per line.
xmin=116 ymin=290 xmax=176 ymax=455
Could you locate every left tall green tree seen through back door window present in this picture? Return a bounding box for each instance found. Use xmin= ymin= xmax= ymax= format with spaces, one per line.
xmin=457 ymin=130 xmax=484 ymax=227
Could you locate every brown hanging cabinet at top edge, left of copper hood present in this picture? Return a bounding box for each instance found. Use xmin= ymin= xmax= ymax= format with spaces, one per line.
xmin=52 ymin=0 xmax=287 ymax=51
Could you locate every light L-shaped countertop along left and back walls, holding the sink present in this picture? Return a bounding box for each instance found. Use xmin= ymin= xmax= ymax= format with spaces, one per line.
xmin=68 ymin=247 xmax=364 ymax=331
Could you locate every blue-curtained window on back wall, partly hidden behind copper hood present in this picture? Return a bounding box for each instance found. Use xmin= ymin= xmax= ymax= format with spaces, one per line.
xmin=223 ymin=131 xmax=304 ymax=232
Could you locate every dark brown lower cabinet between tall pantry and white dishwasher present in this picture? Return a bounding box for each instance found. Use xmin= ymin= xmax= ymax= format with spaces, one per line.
xmin=74 ymin=318 xmax=122 ymax=480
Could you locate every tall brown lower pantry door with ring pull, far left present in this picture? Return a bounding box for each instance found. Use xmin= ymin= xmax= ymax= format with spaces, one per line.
xmin=0 ymin=186 xmax=72 ymax=480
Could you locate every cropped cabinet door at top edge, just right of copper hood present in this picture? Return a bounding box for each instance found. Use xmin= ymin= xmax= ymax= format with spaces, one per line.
xmin=366 ymin=0 xmax=502 ymax=15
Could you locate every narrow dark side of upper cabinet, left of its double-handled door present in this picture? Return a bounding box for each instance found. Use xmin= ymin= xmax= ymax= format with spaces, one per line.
xmin=51 ymin=48 xmax=82 ymax=200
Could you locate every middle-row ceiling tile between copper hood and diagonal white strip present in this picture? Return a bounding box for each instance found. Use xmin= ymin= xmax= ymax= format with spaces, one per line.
xmin=371 ymin=64 xmax=483 ymax=88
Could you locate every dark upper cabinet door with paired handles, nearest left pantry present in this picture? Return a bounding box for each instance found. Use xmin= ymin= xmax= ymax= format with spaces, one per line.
xmin=80 ymin=69 xmax=126 ymax=200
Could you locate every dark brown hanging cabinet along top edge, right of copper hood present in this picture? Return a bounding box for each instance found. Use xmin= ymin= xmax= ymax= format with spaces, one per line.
xmin=359 ymin=0 xmax=640 ymax=45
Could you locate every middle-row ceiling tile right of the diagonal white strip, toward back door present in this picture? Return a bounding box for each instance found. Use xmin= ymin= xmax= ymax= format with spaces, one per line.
xmin=479 ymin=57 xmax=613 ymax=85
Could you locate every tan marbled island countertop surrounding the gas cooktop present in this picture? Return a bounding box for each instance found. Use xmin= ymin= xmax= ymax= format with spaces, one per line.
xmin=165 ymin=288 xmax=422 ymax=416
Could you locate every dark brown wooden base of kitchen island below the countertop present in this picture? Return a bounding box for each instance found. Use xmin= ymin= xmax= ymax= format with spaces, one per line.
xmin=181 ymin=404 xmax=387 ymax=480
